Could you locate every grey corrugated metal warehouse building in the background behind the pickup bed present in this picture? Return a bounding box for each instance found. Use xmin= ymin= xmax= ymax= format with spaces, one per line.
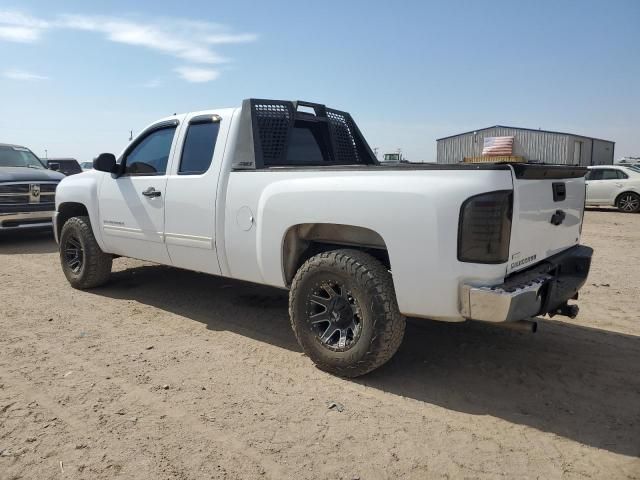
xmin=437 ymin=125 xmax=615 ymax=165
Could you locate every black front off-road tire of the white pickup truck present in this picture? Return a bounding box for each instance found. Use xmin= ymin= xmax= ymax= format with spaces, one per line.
xmin=60 ymin=216 xmax=113 ymax=290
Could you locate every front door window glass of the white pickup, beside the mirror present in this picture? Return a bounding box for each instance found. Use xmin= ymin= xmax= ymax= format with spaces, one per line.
xmin=124 ymin=127 xmax=176 ymax=175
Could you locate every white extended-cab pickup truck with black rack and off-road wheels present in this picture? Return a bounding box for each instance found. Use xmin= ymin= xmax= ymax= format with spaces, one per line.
xmin=54 ymin=99 xmax=592 ymax=377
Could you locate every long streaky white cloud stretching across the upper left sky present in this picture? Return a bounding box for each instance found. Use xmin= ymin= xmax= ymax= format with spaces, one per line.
xmin=0 ymin=10 xmax=257 ymax=82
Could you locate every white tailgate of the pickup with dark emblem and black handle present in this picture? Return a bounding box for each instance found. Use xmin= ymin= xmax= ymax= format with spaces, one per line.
xmin=507 ymin=165 xmax=587 ymax=274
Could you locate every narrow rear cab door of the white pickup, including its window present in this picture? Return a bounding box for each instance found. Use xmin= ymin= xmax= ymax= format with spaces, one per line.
xmin=165 ymin=111 xmax=231 ymax=275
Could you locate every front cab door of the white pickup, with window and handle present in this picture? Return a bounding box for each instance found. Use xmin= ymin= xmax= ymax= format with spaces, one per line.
xmin=98 ymin=120 xmax=178 ymax=264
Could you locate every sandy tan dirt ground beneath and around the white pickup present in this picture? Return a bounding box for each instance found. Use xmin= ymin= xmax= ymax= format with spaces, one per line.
xmin=0 ymin=210 xmax=640 ymax=480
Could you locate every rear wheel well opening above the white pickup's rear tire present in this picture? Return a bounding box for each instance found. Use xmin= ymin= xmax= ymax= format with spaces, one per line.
xmin=282 ymin=223 xmax=391 ymax=286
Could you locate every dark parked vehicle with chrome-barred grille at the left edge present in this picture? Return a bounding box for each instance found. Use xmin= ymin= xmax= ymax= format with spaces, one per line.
xmin=0 ymin=143 xmax=64 ymax=231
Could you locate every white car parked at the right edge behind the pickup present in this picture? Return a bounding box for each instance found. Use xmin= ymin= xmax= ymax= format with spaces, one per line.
xmin=586 ymin=165 xmax=640 ymax=213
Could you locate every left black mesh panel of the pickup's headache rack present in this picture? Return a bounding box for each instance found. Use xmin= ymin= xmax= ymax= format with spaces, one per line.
xmin=253 ymin=101 xmax=295 ymax=165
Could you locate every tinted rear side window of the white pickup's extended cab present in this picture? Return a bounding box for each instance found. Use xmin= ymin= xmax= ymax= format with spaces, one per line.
xmin=178 ymin=122 xmax=220 ymax=175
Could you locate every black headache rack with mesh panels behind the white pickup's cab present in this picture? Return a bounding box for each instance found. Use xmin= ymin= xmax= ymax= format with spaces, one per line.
xmin=233 ymin=98 xmax=378 ymax=170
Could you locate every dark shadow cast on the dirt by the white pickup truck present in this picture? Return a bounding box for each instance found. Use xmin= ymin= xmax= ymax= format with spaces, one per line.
xmin=93 ymin=266 xmax=640 ymax=456
